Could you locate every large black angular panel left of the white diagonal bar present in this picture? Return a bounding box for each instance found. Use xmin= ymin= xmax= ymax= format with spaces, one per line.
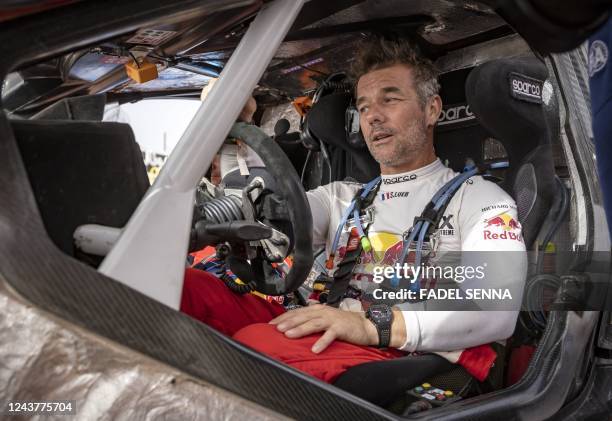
xmin=11 ymin=120 xmax=149 ymax=263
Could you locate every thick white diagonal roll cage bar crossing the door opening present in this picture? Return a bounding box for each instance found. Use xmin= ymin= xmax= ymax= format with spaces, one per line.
xmin=99 ymin=0 xmax=303 ymax=309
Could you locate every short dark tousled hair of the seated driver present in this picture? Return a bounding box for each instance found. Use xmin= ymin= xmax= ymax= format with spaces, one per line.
xmin=351 ymin=35 xmax=440 ymax=106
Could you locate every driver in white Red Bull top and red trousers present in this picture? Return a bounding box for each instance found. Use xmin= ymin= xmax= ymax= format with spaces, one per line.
xmin=181 ymin=34 xmax=526 ymax=396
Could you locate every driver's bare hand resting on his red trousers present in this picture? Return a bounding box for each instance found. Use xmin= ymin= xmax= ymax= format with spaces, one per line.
xmin=270 ymin=304 xmax=378 ymax=354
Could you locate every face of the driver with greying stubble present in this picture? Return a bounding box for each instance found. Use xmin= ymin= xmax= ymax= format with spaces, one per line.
xmin=356 ymin=64 xmax=432 ymax=173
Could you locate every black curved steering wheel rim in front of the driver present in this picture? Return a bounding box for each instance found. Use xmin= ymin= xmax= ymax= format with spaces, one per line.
xmin=221 ymin=123 xmax=314 ymax=295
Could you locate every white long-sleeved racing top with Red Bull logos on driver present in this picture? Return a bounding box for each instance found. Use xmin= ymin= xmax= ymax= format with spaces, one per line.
xmin=307 ymin=160 xmax=527 ymax=377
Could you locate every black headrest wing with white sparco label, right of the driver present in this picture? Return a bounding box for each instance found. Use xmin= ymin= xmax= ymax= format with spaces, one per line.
xmin=465 ymin=58 xmax=553 ymax=164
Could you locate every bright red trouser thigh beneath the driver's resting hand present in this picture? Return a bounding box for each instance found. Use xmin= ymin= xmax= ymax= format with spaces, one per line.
xmin=234 ymin=323 xmax=406 ymax=383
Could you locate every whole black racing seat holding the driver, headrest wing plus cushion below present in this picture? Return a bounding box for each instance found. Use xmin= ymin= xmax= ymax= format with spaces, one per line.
xmin=335 ymin=58 xmax=559 ymax=405
